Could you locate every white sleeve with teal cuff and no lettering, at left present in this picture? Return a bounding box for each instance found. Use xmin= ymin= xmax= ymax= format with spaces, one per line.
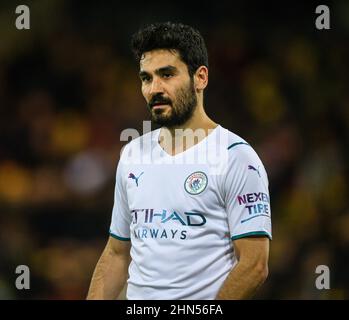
xmin=109 ymin=150 xmax=131 ymax=241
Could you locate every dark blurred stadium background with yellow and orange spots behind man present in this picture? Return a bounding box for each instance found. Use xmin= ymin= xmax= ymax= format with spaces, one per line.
xmin=0 ymin=0 xmax=349 ymax=299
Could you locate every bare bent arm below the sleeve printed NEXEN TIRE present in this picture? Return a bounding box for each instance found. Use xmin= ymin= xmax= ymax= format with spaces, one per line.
xmin=217 ymin=237 xmax=269 ymax=300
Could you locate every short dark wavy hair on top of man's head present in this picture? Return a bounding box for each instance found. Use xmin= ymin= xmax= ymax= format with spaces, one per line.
xmin=131 ymin=22 xmax=208 ymax=77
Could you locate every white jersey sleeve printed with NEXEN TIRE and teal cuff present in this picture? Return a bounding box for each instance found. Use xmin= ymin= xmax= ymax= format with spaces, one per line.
xmin=224 ymin=144 xmax=272 ymax=240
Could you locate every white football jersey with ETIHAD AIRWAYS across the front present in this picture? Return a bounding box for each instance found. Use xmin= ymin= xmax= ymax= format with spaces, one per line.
xmin=110 ymin=126 xmax=271 ymax=300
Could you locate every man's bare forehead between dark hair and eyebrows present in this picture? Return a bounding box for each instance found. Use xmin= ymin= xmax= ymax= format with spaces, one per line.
xmin=139 ymin=49 xmax=186 ymax=71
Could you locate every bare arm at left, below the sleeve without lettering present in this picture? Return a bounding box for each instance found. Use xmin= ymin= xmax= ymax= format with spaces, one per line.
xmin=87 ymin=237 xmax=131 ymax=300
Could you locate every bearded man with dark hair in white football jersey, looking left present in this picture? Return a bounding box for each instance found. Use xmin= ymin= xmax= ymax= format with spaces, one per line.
xmin=88 ymin=22 xmax=271 ymax=300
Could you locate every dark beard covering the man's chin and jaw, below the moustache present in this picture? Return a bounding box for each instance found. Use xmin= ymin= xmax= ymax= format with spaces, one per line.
xmin=146 ymin=79 xmax=197 ymax=128
